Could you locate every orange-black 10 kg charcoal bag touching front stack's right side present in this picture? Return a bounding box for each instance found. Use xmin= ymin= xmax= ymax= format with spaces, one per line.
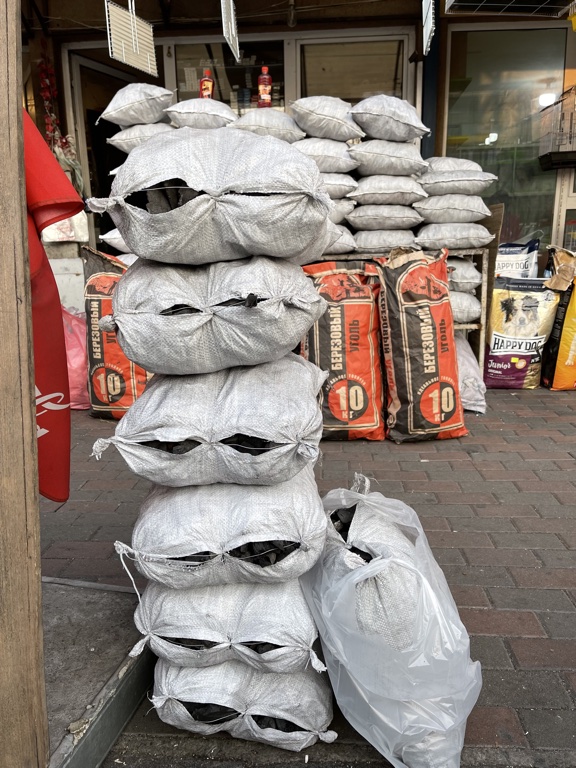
xmin=304 ymin=261 xmax=384 ymax=440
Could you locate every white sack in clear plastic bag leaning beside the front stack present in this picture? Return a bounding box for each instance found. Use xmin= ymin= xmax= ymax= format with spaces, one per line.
xmin=301 ymin=476 xmax=481 ymax=768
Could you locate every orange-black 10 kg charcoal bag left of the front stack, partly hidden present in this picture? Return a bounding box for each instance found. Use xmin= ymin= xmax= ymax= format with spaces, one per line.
xmin=82 ymin=246 xmax=151 ymax=419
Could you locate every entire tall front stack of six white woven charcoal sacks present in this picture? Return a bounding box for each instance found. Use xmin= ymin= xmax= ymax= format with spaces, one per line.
xmin=89 ymin=120 xmax=336 ymax=751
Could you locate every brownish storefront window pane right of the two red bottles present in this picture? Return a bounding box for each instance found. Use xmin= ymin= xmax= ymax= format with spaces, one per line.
xmin=300 ymin=40 xmax=404 ymax=104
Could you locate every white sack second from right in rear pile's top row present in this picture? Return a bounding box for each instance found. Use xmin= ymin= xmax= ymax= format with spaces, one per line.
xmin=290 ymin=96 xmax=366 ymax=141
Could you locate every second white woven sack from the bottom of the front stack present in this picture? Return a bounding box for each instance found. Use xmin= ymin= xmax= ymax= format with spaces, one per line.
xmin=130 ymin=579 xmax=325 ymax=673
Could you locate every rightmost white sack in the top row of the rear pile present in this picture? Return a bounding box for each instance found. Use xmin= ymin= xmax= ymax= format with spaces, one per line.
xmin=352 ymin=94 xmax=430 ymax=142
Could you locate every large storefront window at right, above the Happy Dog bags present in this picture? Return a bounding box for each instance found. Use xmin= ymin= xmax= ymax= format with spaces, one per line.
xmin=446 ymin=29 xmax=566 ymax=243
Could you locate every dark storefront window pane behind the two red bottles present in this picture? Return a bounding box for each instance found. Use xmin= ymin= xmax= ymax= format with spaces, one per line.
xmin=175 ymin=40 xmax=284 ymax=114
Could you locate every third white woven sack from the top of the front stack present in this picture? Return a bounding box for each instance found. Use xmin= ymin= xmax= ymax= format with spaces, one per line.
xmin=93 ymin=353 xmax=327 ymax=486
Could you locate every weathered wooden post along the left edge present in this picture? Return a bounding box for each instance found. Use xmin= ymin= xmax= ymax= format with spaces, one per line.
xmin=0 ymin=0 xmax=48 ymax=768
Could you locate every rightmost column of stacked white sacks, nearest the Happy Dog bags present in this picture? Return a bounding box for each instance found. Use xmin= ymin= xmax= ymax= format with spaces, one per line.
xmin=414 ymin=157 xmax=496 ymax=324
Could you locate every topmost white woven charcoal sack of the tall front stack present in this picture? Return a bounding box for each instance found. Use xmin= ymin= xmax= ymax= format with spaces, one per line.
xmin=89 ymin=128 xmax=331 ymax=264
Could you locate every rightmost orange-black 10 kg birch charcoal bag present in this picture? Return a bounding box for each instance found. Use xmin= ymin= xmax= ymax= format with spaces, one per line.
xmin=377 ymin=248 xmax=468 ymax=443
